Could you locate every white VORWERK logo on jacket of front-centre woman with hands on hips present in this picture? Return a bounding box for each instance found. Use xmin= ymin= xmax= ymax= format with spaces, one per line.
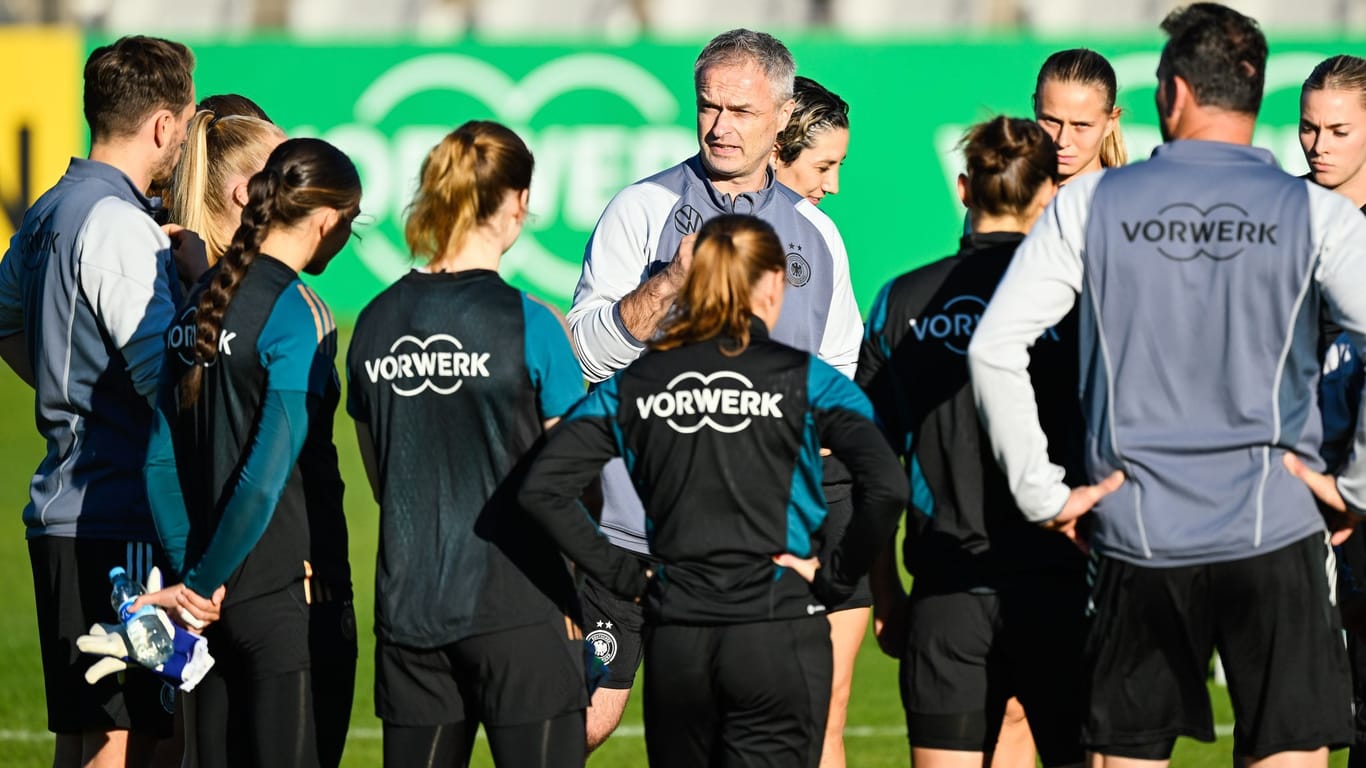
xmin=635 ymin=370 xmax=783 ymax=435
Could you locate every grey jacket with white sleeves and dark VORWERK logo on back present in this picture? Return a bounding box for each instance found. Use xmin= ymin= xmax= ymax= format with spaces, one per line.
xmin=968 ymin=141 xmax=1366 ymax=566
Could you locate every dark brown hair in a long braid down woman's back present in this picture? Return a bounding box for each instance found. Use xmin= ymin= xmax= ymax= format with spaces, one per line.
xmin=180 ymin=138 xmax=361 ymax=409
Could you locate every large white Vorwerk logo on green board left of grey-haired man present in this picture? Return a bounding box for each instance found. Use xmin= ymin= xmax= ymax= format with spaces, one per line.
xmin=310 ymin=53 xmax=697 ymax=299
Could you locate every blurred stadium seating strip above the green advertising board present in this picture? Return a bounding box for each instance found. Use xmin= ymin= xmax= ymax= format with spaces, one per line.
xmin=0 ymin=0 xmax=1366 ymax=40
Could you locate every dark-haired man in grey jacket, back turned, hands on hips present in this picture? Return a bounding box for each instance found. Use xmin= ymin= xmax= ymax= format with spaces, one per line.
xmin=968 ymin=3 xmax=1366 ymax=765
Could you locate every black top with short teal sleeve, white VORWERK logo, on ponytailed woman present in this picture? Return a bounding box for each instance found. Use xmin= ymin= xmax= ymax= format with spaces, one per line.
xmin=347 ymin=269 xmax=583 ymax=648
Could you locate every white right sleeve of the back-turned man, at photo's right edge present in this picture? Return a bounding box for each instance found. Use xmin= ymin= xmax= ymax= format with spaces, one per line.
xmin=1306 ymin=182 xmax=1366 ymax=514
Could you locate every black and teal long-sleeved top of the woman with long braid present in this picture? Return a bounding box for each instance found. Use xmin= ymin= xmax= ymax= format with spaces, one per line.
xmin=146 ymin=254 xmax=341 ymax=603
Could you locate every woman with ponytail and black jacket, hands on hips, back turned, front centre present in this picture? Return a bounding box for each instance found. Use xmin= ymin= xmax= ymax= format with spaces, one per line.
xmin=520 ymin=215 xmax=906 ymax=768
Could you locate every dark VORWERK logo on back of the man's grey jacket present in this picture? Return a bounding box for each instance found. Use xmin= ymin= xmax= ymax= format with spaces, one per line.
xmin=1120 ymin=202 xmax=1276 ymax=261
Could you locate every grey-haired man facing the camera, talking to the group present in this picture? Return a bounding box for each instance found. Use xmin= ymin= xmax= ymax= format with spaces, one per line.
xmin=567 ymin=29 xmax=866 ymax=750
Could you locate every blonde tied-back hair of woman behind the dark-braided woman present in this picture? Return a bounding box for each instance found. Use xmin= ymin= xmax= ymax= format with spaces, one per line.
xmin=169 ymin=111 xmax=284 ymax=261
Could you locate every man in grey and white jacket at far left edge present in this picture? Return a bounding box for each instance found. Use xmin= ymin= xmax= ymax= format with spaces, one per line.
xmin=0 ymin=37 xmax=205 ymax=765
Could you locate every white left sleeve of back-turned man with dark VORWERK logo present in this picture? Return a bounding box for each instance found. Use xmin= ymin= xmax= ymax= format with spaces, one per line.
xmin=967 ymin=172 xmax=1104 ymax=522
